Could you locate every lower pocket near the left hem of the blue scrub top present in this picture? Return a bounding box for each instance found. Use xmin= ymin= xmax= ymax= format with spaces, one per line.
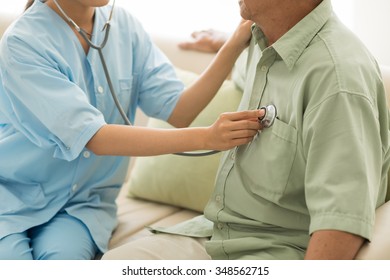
xmin=0 ymin=177 xmax=46 ymax=214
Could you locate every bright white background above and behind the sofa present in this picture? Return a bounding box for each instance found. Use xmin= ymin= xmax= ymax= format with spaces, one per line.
xmin=1 ymin=0 xmax=390 ymax=65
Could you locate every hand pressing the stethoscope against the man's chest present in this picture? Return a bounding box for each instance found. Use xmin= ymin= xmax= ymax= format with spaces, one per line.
xmin=205 ymin=109 xmax=265 ymax=151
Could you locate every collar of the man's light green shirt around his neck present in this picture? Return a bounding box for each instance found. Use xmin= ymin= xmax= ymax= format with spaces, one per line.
xmin=252 ymin=0 xmax=333 ymax=70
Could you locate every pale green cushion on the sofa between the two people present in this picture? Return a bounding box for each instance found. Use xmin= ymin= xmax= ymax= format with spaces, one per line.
xmin=125 ymin=69 xmax=242 ymax=212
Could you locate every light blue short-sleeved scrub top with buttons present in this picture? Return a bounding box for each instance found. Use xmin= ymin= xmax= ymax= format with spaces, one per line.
xmin=0 ymin=1 xmax=183 ymax=252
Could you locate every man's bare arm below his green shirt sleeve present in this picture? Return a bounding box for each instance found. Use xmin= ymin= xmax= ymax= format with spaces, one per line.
xmin=305 ymin=230 xmax=364 ymax=260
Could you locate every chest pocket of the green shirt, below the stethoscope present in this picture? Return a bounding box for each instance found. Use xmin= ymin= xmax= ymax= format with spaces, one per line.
xmin=237 ymin=119 xmax=297 ymax=202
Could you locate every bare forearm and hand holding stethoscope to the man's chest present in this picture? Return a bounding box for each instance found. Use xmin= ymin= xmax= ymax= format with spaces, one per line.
xmin=86 ymin=110 xmax=264 ymax=156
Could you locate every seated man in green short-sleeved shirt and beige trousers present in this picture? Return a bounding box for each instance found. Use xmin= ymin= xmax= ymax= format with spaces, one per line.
xmin=104 ymin=0 xmax=389 ymax=259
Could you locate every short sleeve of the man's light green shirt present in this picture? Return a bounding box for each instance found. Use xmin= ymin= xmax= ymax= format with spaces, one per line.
xmin=303 ymin=92 xmax=383 ymax=239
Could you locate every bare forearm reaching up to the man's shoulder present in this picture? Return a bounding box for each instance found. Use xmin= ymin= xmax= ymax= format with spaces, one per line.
xmin=168 ymin=20 xmax=252 ymax=127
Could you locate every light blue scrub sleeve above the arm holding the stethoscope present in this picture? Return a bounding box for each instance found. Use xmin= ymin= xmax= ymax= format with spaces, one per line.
xmin=0 ymin=36 xmax=105 ymax=161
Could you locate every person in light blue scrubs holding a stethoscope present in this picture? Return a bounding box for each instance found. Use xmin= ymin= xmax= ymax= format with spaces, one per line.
xmin=0 ymin=0 xmax=264 ymax=259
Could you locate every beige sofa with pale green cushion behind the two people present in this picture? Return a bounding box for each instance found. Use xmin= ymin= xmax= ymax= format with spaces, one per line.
xmin=0 ymin=12 xmax=390 ymax=260
